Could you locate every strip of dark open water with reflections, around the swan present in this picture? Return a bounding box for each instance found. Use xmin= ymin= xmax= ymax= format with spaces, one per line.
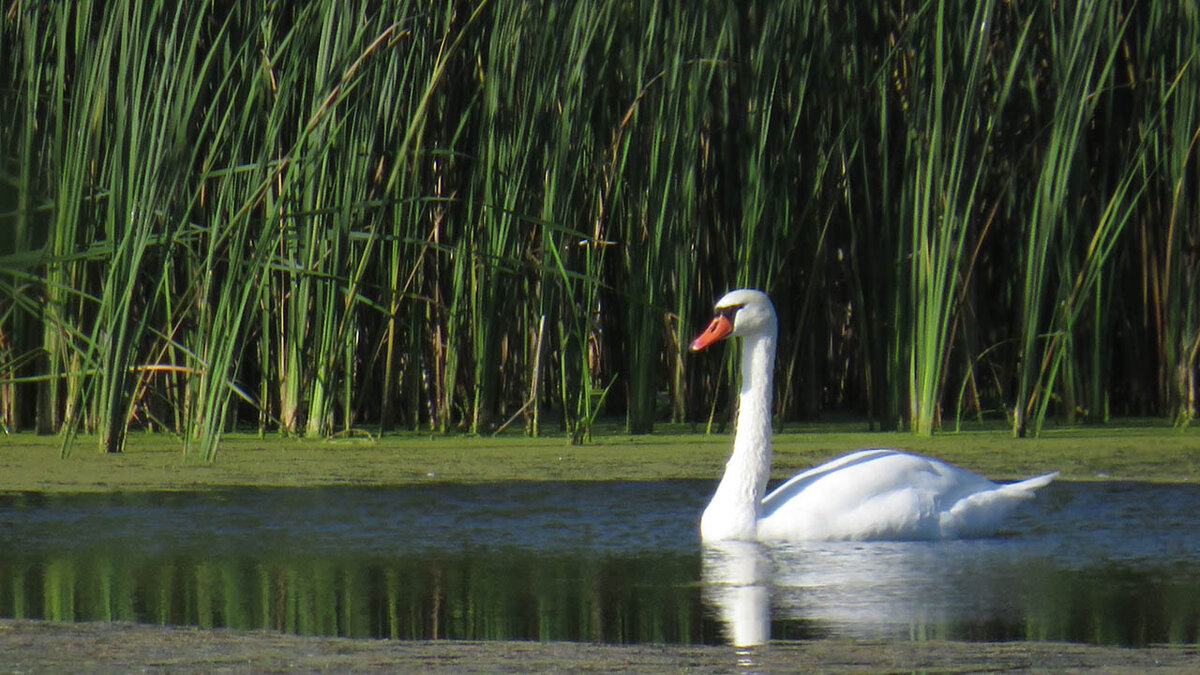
xmin=0 ymin=480 xmax=1200 ymax=645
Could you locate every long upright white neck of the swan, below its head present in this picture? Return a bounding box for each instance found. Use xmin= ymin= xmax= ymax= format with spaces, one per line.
xmin=700 ymin=330 xmax=775 ymax=540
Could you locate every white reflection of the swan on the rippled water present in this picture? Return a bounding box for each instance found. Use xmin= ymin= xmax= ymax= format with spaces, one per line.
xmin=701 ymin=530 xmax=1046 ymax=647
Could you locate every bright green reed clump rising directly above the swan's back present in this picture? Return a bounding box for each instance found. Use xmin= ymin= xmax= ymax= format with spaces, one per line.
xmin=907 ymin=2 xmax=1031 ymax=435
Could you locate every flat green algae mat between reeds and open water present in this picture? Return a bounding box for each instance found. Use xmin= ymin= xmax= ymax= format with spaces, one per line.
xmin=0 ymin=420 xmax=1200 ymax=492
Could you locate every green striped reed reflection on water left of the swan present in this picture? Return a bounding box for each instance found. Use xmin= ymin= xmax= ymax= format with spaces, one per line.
xmin=0 ymin=550 xmax=715 ymax=643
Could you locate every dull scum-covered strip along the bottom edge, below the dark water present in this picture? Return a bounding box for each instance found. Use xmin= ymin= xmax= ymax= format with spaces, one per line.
xmin=0 ymin=620 xmax=1200 ymax=674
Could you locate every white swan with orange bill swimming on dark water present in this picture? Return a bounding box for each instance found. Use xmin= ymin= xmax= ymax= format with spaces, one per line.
xmin=691 ymin=289 xmax=1058 ymax=542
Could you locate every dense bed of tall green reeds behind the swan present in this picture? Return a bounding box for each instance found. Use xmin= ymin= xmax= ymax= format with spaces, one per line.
xmin=0 ymin=0 xmax=1200 ymax=458
